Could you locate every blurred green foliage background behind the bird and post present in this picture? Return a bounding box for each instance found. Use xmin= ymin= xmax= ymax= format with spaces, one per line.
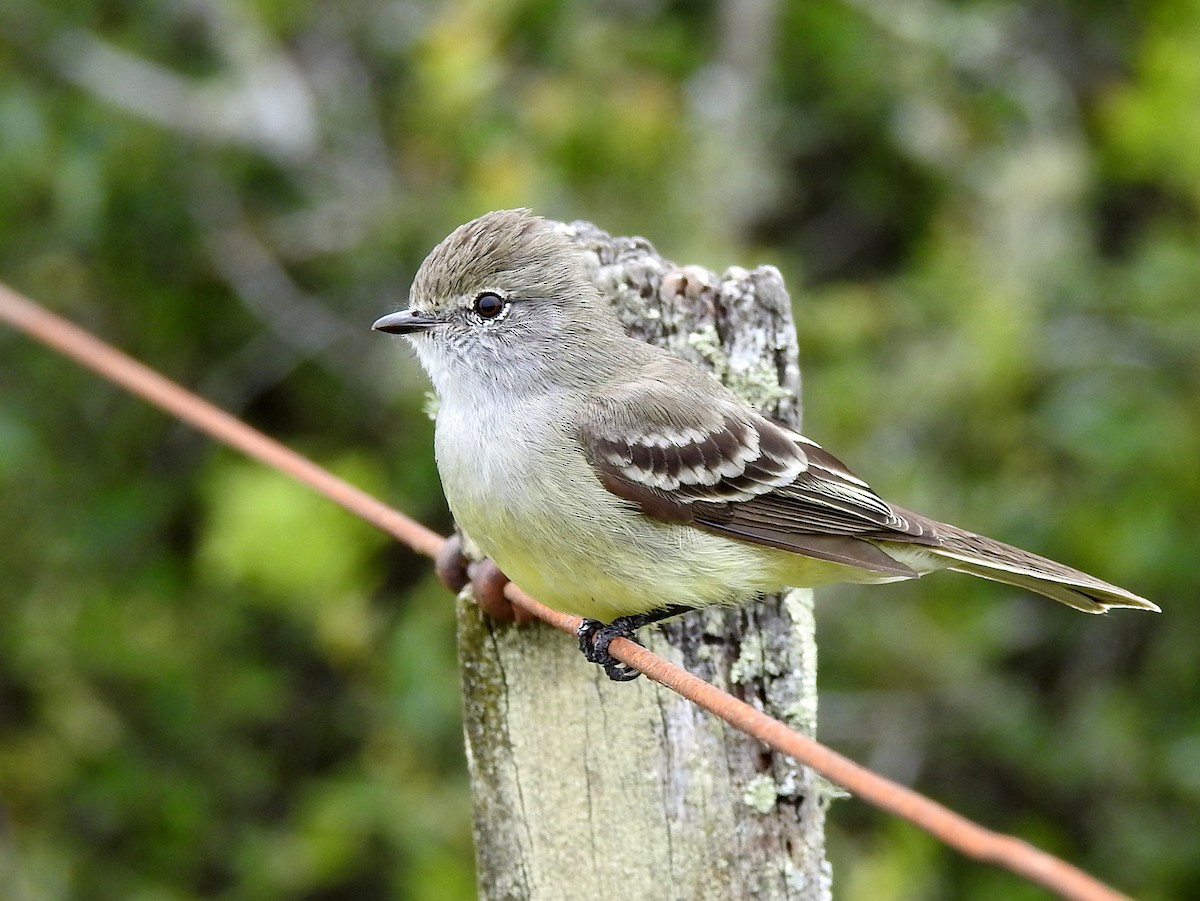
xmin=0 ymin=0 xmax=1200 ymax=901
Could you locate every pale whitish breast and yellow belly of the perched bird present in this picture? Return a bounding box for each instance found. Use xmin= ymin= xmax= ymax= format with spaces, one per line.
xmin=437 ymin=406 xmax=873 ymax=621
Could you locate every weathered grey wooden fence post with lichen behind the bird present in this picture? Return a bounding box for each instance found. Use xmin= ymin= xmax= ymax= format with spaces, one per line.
xmin=458 ymin=222 xmax=830 ymax=901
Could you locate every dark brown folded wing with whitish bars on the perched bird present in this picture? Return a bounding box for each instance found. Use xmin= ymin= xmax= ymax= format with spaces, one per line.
xmin=578 ymin=379 xmax=936 ymax=577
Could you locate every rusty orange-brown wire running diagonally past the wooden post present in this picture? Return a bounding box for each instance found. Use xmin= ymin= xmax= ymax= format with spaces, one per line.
xmin=0 ymin=283 xmax=1130 ymax=901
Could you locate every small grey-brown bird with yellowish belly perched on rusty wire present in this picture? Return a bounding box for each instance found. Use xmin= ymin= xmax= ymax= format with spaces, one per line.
xmin=373 ymin=210 xmax=1159 ymax=681
